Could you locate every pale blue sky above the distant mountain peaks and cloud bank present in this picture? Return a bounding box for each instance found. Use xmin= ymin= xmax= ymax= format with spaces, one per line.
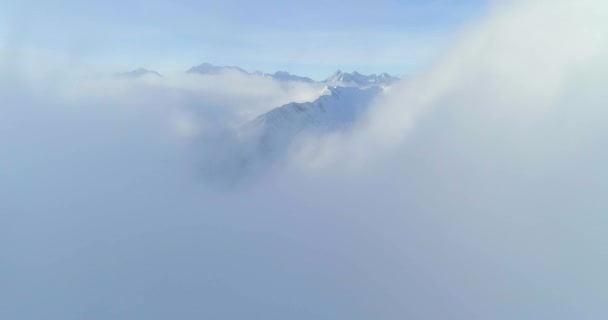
xmin=0 ymin=0 xmax=487 ymax=78
